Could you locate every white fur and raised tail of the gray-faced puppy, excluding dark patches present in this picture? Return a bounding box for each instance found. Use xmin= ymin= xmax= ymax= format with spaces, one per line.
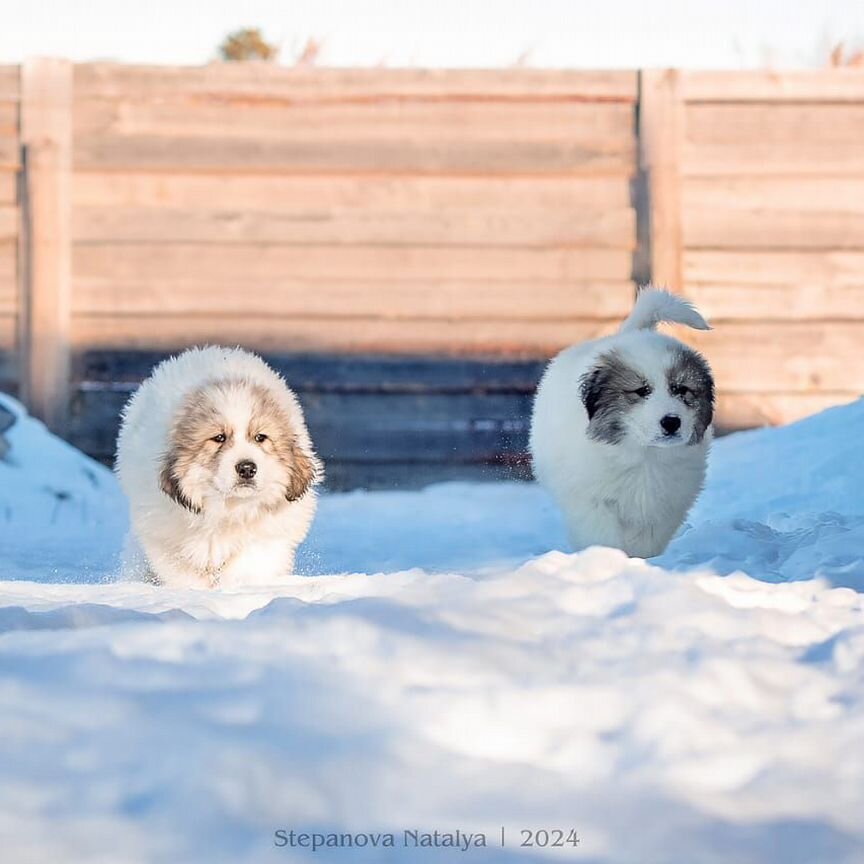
xmin=531 ymin=288 xmax=712 ymax=557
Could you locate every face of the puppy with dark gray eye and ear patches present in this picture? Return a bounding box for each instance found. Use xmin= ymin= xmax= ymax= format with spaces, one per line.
xmin=581 ymin=344 xmax=714 ymax=447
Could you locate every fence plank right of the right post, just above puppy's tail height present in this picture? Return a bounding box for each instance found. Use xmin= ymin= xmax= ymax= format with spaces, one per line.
xmin=684 ymin=249 xmax=864 ymax=287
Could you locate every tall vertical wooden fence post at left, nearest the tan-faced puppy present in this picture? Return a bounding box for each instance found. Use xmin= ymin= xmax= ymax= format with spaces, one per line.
xmin=20 ymin=58 xmax=72 ymax=432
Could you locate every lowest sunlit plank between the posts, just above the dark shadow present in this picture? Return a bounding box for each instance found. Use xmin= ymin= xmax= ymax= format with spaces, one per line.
xmin=72 ymin=314 xmax=620 ymax=357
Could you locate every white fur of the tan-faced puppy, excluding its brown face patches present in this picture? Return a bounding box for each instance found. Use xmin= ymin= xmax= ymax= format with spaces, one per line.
xmin=116 ymin=347 xmax=318 ymax=587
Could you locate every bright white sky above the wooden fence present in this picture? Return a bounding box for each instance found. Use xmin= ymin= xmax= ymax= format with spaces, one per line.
xmin=0 ymin=0 xmax=864 ymax=68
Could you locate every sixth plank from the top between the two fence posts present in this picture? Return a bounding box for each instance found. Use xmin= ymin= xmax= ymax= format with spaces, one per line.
xmin=73 ymin=243 xmax=631 ymax=287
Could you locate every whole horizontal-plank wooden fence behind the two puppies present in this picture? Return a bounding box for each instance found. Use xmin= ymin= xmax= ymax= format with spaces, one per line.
xmin=0 ymin=60 xmax=864 ymax=485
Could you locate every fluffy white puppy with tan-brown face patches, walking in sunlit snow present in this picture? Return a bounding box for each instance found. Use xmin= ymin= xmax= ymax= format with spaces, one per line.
xmin=116 ymin=347 xmax=322 ymax=587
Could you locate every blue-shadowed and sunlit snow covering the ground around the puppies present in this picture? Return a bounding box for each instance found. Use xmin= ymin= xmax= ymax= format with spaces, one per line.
xmin=0 ymin=397 xmax=864 ymax=864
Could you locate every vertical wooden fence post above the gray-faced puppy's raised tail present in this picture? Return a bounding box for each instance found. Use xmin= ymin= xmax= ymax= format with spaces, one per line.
xmin=639 ymin=69 xmax=684 ymax=291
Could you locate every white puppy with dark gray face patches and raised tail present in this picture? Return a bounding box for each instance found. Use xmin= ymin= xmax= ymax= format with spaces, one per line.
xmin=531 ymin=288 xmax=714 ymax=558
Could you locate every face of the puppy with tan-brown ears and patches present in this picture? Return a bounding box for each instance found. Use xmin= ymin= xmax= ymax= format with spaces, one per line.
xmin=160 ymin=381 xmax=320 ymax=512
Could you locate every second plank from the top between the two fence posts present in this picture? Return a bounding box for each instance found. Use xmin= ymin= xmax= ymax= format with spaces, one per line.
xmin=74 ymin=94 xmax=634 ymax=144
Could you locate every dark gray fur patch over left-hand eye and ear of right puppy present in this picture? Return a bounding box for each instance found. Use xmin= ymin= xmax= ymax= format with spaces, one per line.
xmin=581 ymin=351 xmax=650 ymax=444
